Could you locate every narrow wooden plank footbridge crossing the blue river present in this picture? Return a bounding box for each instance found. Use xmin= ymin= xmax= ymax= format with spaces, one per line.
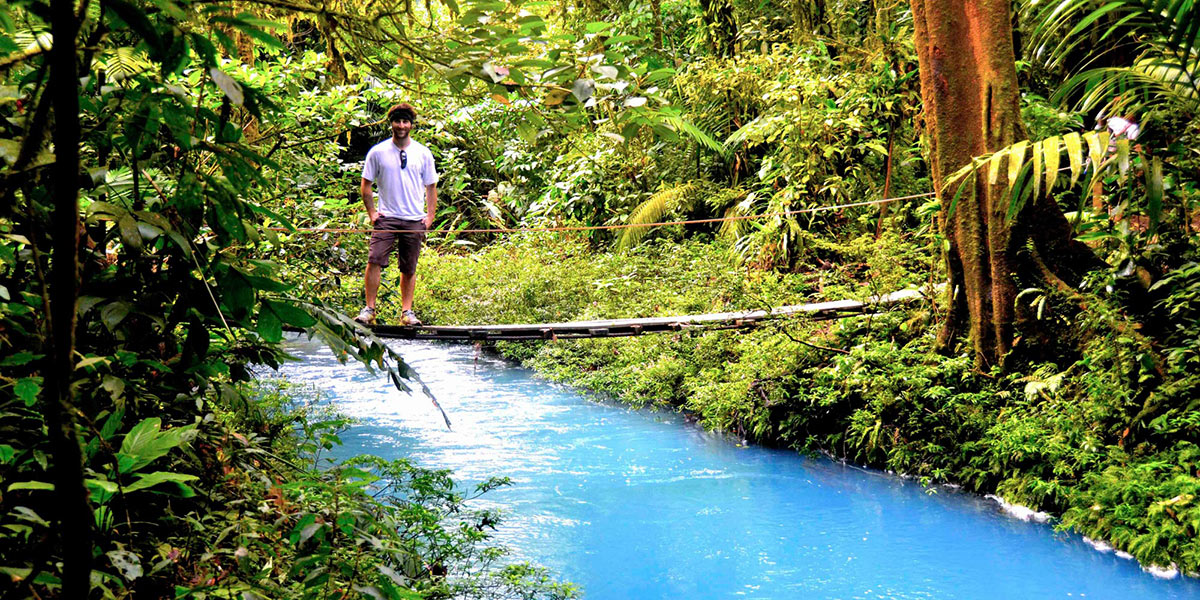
xmin=371 ymin=289 xmax=924 ymax=341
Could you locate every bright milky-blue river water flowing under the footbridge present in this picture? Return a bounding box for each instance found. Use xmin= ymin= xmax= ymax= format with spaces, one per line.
xmin=284 ymin=340 xmax=1200 ymax=600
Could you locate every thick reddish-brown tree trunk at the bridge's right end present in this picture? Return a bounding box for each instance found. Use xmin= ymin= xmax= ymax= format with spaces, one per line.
xmin=911 ymin=0 xmax=1097 ymax=368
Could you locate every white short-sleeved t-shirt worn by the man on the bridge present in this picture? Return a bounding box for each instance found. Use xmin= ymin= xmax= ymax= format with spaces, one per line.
xmin=362 ymin=138 xmax=438 ymax=221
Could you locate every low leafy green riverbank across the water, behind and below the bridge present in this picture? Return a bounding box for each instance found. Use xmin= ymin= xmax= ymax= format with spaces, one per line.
xmin=400 ymin=236 xmax=1200 ymax=572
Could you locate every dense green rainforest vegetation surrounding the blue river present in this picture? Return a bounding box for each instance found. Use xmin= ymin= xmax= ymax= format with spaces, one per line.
xmin=0 ymin=0 xmax=1200 ymax=598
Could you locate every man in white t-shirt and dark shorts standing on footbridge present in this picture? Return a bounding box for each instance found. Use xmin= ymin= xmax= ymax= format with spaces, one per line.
xmin=354 ymin=103 xmax=438 ymax=325
